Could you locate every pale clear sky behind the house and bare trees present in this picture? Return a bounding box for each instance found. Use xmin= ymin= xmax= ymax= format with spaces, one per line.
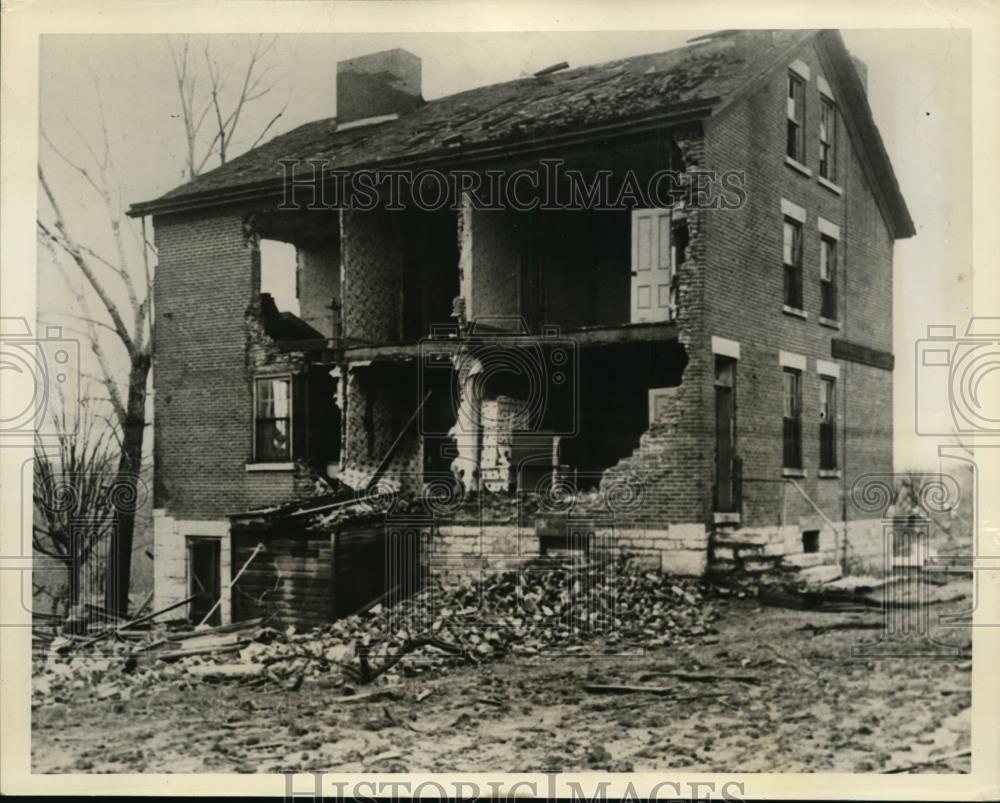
xmin=38 ymin=29 xmax=968 ymax=469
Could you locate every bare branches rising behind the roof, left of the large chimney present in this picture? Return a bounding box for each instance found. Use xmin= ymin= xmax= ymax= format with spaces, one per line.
xmin=167 ymin=36 xmax=288 ymax=178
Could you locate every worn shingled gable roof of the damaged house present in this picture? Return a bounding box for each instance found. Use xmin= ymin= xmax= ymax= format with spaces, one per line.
xmin=129 ymin=30 xmax=913 ymax=236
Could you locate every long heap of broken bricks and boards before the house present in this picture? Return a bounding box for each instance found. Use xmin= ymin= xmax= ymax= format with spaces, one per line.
xmin=34 ymin=560 xmax=717 ymax=701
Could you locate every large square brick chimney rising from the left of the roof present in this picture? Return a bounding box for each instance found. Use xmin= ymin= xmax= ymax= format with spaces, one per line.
xmin=337 ymin=48 xmax=424 ymax=123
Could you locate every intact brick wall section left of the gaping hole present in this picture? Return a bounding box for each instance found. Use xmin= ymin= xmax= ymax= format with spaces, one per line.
xmin=153 ymin=210 xmax=311 ymax=519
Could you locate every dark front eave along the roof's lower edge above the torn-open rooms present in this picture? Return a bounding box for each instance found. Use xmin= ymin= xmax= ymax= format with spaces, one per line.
xmin=126 ymin=97 xmax=720 ymax=217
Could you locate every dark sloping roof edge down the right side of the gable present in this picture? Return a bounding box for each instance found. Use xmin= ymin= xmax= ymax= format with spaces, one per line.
xmin=817 ymin=29 xmax=917 ymax=240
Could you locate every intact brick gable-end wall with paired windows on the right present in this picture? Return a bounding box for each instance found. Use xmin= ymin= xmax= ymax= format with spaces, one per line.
xmin=700 ymin=39 xmax=892 ymax=540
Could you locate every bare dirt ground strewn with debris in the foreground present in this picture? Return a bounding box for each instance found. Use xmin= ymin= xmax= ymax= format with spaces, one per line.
xmin=32 ymin=579 xmax=971 ymax=773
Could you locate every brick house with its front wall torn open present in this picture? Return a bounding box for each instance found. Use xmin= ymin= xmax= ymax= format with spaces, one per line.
xmin=131 ymin=31 xmax=914 ymax=622
